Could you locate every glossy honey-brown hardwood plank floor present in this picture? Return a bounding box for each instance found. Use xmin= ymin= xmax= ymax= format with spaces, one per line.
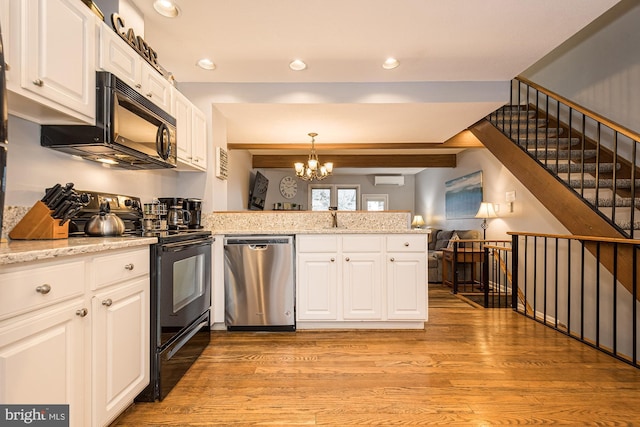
xmin=113 ymin=285 xmax=640 ymax=427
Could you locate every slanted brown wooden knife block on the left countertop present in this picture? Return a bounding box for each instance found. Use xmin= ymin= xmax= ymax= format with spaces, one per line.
xmin=9 ymin=200 xmax=69 ymax=240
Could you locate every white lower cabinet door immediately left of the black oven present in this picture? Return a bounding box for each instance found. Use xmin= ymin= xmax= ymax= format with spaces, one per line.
xmin=91 ymin=276 xmax=150 ymax=426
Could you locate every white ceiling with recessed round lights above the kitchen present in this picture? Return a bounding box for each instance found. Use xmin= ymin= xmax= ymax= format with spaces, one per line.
xmin=127 ymin=0 xmax=618 ymax=171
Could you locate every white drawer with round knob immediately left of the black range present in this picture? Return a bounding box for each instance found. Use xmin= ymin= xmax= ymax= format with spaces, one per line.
xmin=91 ymin=247 xmax=150 ymax=290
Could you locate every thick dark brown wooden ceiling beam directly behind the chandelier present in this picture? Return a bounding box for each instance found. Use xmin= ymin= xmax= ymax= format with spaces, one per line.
xmin=253 ymin=154 xmax=456 ymax=169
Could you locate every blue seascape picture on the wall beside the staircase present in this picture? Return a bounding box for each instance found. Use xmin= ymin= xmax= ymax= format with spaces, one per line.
xmin=445 ymin=171 xmax=482 ymax=219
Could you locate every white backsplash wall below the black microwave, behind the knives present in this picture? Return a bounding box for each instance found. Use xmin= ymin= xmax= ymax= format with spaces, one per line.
xmin=5 ymin=116 xmax=179 ymax=206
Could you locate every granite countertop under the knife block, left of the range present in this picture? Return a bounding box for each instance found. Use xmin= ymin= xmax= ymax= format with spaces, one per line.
xmin=0 ymin=237 xmax=158 ymax=265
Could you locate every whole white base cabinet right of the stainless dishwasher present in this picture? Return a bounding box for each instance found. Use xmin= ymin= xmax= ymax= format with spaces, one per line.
xmin=296 ymin=234 xmax=427 ymax=328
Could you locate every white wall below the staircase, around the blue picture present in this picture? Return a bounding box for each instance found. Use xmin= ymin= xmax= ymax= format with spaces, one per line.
xmin=415 ymin=148 xmax=568 ymax=239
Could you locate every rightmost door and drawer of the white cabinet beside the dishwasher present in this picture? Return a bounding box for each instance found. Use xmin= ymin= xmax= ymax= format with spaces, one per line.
xmin=386 ymin=234 xmax=427 ymax=320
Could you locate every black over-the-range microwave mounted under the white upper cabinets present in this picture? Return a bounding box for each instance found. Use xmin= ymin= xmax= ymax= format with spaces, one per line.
xmin=40 ymin=71 xmax=177 ymax=169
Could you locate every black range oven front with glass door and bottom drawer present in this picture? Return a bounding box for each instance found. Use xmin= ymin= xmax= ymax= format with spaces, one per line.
xmin=136 ymin=230 xmax=213 ymax=402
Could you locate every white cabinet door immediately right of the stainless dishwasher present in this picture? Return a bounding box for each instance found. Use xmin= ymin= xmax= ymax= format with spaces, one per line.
xmin=296 ymin=253 xmax=338 ymax=320
